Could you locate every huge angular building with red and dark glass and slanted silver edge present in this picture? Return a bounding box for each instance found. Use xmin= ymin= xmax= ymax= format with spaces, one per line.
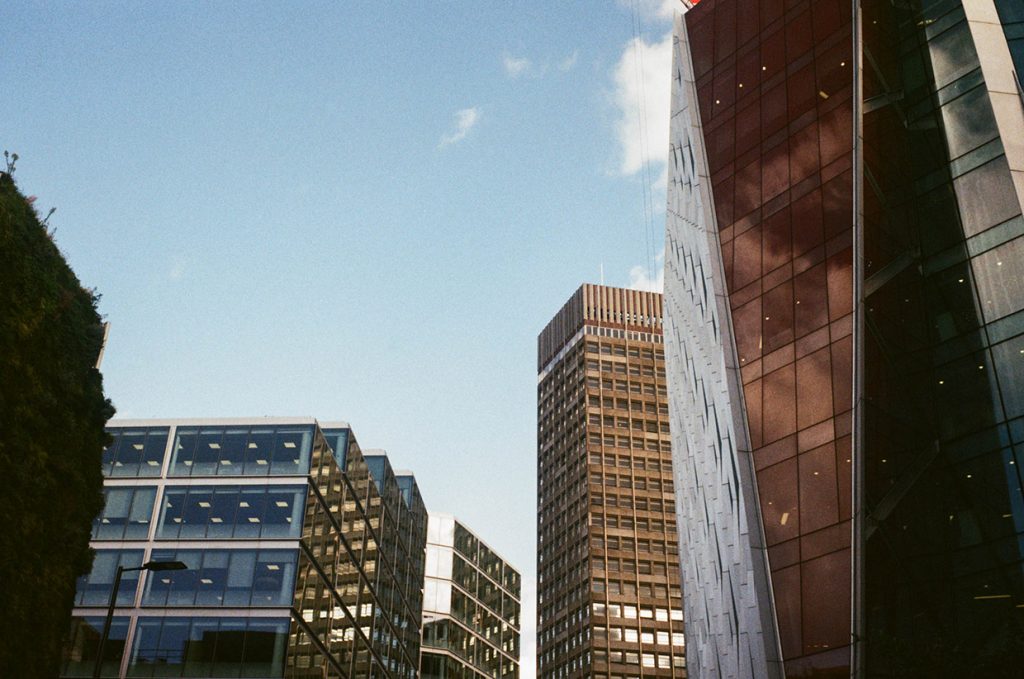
xmin=666 ymin=0 xmax=1024 ymax=677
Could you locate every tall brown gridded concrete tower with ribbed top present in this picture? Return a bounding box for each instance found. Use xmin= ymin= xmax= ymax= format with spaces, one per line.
xmin=537 ymin=285 xmax=686 ymax=678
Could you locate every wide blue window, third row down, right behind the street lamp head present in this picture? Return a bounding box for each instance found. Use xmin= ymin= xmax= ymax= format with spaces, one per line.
xmin=142 ymin=549 xmax=298 ymax=606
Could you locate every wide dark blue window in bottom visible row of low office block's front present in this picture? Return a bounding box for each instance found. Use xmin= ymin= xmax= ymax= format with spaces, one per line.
xmin=128 ymin=618 xmax=289 ymax=679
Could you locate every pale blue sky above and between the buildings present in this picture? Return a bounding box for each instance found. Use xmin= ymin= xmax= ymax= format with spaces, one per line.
xmin=6 ymin=0 xmax=671 ymax=677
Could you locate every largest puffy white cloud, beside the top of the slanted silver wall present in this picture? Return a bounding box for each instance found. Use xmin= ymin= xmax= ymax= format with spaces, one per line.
xmin=612 ymin=32 xmax=672 ymax=186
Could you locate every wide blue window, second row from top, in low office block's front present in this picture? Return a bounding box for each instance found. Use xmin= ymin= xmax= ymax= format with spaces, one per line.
xmin=157 ymin=485 xmax=306 ymax=540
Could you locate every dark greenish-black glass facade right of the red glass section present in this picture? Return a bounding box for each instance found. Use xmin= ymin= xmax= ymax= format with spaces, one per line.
xmin=862 ymin=0 xmax=1024 ymax=677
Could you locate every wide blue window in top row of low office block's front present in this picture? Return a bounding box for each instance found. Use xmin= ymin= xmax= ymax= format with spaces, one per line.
xmin=170 ymin=426 xmax=312 ymax=476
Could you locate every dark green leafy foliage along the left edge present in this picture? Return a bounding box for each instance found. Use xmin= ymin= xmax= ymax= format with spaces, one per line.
xmin=0 ymin=166 xmax=114 ymax=677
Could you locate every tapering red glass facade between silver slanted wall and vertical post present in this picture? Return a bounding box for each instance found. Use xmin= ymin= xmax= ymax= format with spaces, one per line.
xmin=684 ymin=0 xmax=854 ymax=677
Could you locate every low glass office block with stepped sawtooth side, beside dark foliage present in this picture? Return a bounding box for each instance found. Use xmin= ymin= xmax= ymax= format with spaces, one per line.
xmin=62 ymin=418 xmax=426 ymax=679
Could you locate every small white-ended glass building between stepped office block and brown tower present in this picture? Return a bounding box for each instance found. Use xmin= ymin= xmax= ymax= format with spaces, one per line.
xmin=420 ymin=512 xmax=521 ymax=679
